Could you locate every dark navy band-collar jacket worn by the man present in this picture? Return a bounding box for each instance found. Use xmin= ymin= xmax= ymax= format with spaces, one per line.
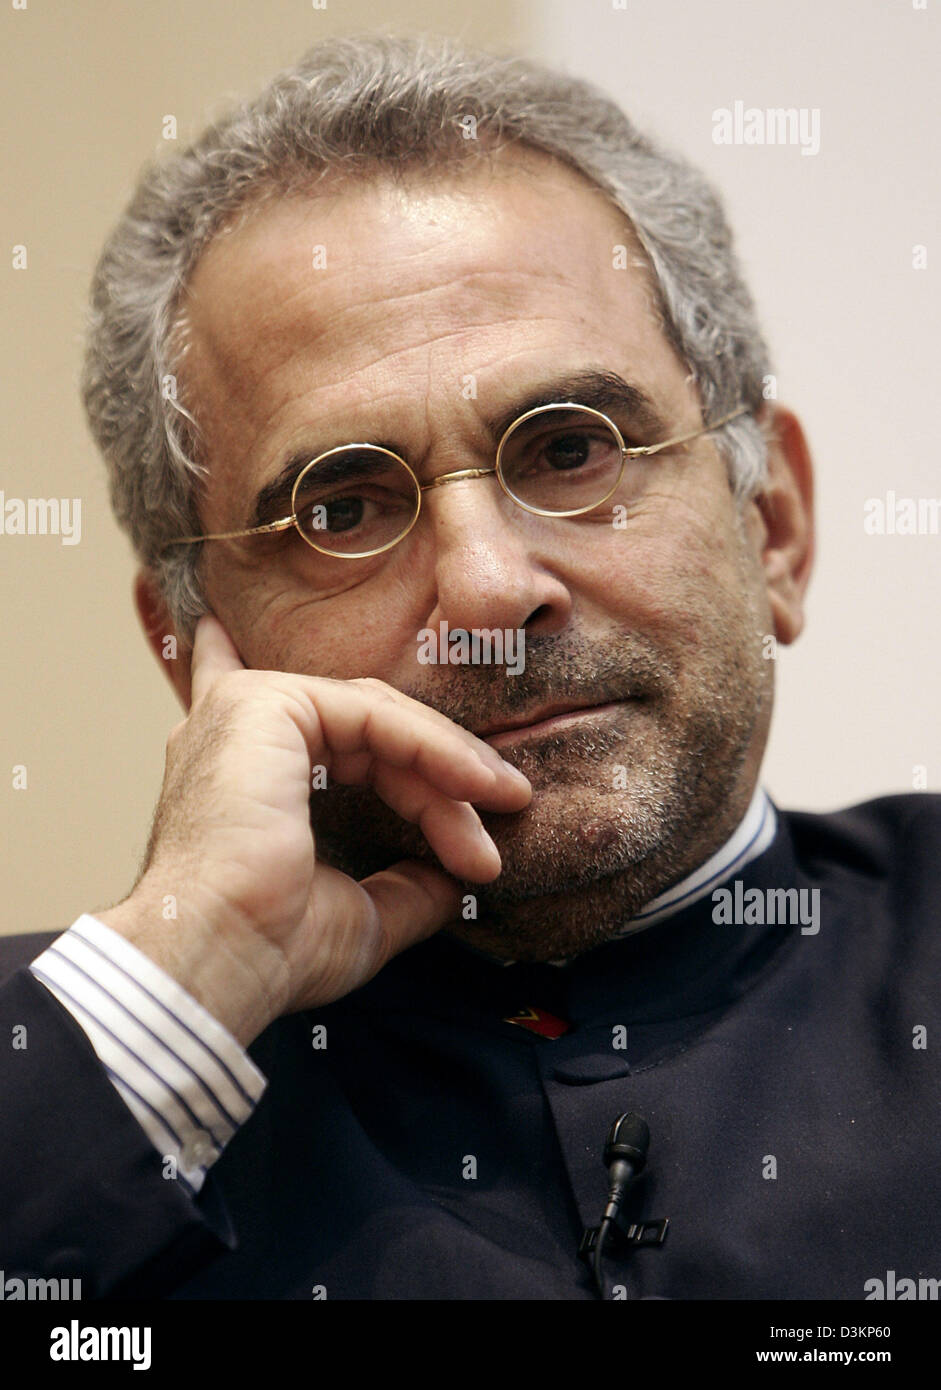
xmin=0 ymin=795 xmax=941 ymax=1300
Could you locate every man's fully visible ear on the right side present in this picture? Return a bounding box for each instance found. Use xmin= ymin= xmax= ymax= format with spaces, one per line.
xmin=751 ymin=406 xmax=815 ymax=645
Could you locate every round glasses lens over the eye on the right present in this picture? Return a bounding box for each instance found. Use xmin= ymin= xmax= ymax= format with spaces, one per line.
xmin=499 ymin=406 xmax=623 ymax=516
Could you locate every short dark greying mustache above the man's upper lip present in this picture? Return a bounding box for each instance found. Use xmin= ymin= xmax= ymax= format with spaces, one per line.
xmin=399 ymin=632 xmax=676 ymax=733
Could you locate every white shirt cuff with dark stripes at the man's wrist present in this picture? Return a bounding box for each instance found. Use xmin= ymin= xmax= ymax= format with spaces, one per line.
xmin=29 ymin=913 xmax=268 ymax=1194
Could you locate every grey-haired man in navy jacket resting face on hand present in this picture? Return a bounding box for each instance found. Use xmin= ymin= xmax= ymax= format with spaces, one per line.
xmin=0 ymin=39 xmax=941 ymax=1300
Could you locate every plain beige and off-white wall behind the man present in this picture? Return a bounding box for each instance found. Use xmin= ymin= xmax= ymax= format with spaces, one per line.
xmin=0 ymin=0 xmax=941 ymax=931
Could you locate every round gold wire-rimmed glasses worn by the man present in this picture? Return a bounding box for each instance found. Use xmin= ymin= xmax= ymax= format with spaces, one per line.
xmin=161 ymin=402 xmax=748 ymax=560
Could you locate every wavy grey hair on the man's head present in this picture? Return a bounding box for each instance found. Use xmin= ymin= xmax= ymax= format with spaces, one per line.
xmin=82 ymin=35 xmax=770 ymax=639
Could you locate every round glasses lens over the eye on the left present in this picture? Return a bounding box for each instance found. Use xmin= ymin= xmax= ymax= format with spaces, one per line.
xmin=293 ymin=445 xmax=420 ymax=560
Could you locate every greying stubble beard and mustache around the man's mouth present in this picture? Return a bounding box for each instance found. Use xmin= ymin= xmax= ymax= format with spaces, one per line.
xmin=311 ymin=547 xmax=771 ymax=960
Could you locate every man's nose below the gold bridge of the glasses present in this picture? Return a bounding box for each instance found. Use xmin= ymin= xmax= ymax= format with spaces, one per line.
xmin=421 ymin=470 xmax=573 ymax=637
